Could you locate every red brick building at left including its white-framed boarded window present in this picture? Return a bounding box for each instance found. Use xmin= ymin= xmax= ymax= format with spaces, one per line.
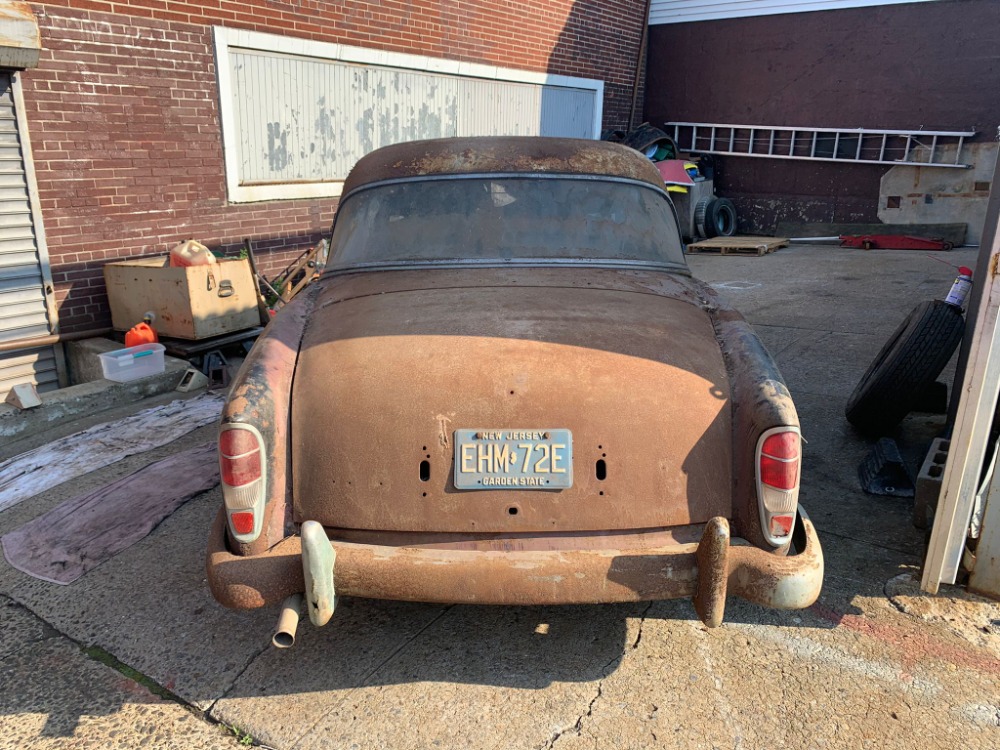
xmin=0 ymin=0 xmax=645 ymax=390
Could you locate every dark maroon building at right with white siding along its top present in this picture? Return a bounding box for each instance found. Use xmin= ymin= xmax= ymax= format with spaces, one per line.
xmin=645 ymin=0 xmax=1000 ymax=238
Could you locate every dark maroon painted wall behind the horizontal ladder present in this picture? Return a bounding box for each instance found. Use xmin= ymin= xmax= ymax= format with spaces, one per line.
xmin=645 ymin=0 xmax=1000 ymax=234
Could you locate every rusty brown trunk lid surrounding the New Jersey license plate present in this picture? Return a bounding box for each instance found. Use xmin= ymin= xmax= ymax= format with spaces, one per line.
xmin=292 ymin=269 xmax=732 ymax=532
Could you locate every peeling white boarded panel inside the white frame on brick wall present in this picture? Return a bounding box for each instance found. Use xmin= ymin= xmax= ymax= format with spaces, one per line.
xmin=229 ymin=49 xmax=598 ymax=186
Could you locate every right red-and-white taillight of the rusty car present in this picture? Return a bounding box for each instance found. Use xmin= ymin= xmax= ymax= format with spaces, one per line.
xmin=757 ymin=427 xmax=802 ymax=547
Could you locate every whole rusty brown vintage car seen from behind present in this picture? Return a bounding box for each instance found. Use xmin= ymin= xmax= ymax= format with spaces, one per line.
xmin=207 ymin=137 xmax=823 ymax=645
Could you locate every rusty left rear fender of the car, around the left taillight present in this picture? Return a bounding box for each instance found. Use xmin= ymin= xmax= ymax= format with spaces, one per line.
xmin=222 ymin=284 xmax=318 ymax=555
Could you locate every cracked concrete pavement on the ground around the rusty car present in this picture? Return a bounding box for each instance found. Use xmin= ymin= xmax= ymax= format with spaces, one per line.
xmin=0 ymin=246 xmax=1000 ymax=750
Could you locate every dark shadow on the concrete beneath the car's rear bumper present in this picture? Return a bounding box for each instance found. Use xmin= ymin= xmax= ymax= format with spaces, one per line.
xmin=211 ymin=572 xmax=881 ymax=700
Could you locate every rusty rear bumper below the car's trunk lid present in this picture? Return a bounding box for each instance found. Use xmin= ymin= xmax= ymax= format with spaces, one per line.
xmin=207 ymin=508 xmax=823 ymax=626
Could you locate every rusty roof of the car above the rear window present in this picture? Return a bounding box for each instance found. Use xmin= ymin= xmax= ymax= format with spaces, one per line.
xmin=343 ymin=136 xmax=663 ymax=196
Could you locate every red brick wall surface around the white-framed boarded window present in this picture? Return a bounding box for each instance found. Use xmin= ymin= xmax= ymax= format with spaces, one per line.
xmin=22 ymin=0 xmax=644 ymax=331
